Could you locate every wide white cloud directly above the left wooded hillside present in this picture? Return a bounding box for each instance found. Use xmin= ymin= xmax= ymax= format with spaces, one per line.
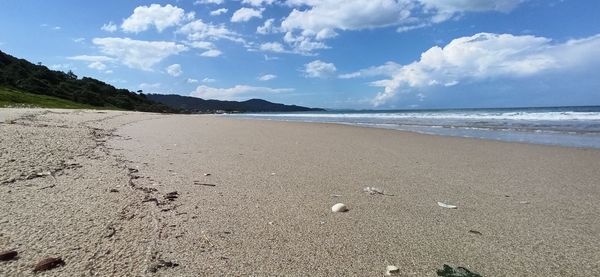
xmin=92 ymin=37 xmax=188 ymax=70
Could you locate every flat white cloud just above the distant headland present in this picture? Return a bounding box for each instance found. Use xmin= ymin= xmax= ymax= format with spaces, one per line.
xmin=191 ymin=85 xmax=294 ymax=100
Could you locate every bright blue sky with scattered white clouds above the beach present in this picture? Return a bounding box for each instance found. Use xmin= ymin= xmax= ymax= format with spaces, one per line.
xmin=0 ymin=0 xmax=600 ymax=109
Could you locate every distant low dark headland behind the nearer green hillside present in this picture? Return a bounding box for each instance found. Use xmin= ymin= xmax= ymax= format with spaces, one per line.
xmin=146 ymin=94 xmax=323 ymax=113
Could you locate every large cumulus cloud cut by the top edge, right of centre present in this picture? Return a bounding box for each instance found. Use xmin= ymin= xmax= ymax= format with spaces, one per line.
xmin=276 ymin=0 xmax=526 ymax=54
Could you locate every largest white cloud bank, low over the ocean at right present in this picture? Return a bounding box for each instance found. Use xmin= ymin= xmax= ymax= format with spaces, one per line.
xmin=356 ymin=33 xmax=600 ymax=105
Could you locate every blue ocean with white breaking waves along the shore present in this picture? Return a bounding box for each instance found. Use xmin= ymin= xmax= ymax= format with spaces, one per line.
xmin=225 ymin=106 xmax=600 ymax=148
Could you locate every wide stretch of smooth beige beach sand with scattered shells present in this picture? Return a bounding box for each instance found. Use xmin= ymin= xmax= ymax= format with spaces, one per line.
xmin=0 ymin=109 xmax=600 ymax=276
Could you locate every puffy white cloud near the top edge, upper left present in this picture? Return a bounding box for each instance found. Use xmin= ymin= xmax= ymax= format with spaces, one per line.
xmin=121 ymin=4 xmax=194 ymax=33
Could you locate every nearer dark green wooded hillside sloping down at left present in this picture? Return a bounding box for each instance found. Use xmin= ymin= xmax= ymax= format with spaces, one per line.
xmin=0 ymin=51 xmax=177 ymax=112
